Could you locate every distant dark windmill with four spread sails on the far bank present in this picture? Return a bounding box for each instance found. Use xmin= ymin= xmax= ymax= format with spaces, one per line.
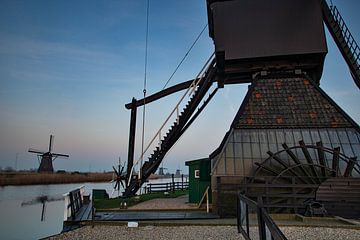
xmin=28 ymin=135 xmax=69 ymax=172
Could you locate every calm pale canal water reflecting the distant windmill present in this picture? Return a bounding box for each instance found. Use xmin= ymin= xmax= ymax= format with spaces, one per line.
xmin=0 ymin=179 xmax=181 ymax=239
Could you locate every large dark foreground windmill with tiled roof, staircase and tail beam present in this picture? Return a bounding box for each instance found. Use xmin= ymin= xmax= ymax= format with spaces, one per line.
xmin=124 ymin=0 xmax=360 ymax=216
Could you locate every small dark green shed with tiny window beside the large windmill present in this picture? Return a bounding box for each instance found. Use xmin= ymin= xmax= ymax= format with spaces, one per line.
xmin=185 ymin=158 xmax=211 ymax=203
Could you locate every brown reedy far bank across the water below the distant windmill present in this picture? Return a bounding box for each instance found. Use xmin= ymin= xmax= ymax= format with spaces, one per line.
xmin=0 ymin=172 xmax=112 ymax=186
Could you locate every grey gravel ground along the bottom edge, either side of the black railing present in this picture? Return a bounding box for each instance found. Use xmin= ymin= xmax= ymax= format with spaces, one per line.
xmin=49 ymin=225 xmax=360 ymax=240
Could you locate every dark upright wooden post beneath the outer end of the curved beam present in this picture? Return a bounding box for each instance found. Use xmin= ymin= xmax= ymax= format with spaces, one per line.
xmin=126 ymin=98 xmax=137 ymax=182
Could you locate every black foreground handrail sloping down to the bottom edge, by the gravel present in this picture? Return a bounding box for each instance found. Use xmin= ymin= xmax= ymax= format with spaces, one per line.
xmin=237 ymin=194 xmax=287 ymax=240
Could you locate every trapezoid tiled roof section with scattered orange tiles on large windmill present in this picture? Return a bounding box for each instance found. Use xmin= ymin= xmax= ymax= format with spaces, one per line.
xmin=233 ymin=77 xmax=358 ymax=128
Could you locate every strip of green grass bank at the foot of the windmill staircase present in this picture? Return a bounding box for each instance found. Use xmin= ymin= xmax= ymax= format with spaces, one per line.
xmin=94 ymin=190 xmax=188 ymax=210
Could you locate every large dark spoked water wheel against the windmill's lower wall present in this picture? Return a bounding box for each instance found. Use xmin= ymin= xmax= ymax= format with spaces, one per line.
xmin=242 ymin=141 xmax=360 ymax=213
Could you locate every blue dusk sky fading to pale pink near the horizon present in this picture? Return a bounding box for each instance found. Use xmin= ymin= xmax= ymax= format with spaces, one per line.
xmin=0 ymin=0 xmax=360 ymax=172
